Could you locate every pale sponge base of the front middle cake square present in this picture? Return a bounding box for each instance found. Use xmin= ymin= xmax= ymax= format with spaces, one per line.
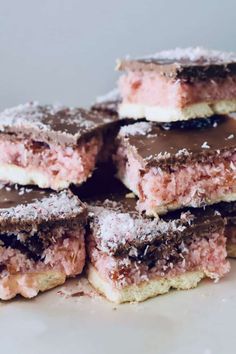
xmin=87 ymin=264 xmax=205 ymax=304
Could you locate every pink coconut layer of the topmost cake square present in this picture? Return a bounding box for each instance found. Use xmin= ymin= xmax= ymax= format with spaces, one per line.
xmin=118 ymin=71 xmax=236 ymax=108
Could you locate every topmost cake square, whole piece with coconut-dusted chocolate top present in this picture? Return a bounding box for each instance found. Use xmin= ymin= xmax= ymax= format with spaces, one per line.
xmin=118 ymin=47 xmax=236 ymax=122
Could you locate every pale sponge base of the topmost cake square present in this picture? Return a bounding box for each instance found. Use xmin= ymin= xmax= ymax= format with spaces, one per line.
xmin=118 ymin=100 xmax=236 ymax=122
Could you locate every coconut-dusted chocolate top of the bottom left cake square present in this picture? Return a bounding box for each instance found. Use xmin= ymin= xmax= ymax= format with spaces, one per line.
xmin=0 ymin=185 xmax=87 ymax=232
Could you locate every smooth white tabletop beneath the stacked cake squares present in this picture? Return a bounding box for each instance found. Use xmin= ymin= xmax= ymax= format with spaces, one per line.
xmin=0 ymin=261 xmax=236 ymax=354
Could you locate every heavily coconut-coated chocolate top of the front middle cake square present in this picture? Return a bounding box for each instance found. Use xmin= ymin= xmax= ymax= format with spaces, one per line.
xmin=88 ymin=193 xmax=223 ymax=257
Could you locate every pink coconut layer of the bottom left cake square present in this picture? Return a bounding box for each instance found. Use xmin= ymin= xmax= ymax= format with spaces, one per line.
xmin=0 ymin=226 xmax=85 ymax=279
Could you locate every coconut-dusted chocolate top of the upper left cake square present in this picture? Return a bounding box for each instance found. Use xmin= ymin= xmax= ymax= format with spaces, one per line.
xmin=0 ymin=102 xmax=117 ymax=145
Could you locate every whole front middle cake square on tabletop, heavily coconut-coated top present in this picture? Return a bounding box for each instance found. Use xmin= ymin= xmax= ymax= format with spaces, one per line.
xmin=87 ymin=189 xmax=229 ymax=303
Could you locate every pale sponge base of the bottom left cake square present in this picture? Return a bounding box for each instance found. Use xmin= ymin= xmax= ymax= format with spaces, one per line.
xmin=0 ymin=270 xmax=66 ymax=300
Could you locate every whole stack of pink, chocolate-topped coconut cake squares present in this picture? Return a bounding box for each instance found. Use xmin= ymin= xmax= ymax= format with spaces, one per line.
xmin=0 ymin=47 xmax=236 ymax=303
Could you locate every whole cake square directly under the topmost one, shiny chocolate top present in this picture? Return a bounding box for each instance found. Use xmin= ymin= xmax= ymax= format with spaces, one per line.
xmin=114 ymin=116 xmax=236 ymax=215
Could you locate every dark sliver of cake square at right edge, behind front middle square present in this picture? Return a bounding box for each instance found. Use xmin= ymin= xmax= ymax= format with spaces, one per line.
xmin=215 ymin=202 xmax=236 ymax=258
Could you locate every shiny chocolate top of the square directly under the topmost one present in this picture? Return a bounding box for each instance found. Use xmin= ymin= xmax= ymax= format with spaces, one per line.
xmin=118 ymin=116 xmax=236 ymax=169
